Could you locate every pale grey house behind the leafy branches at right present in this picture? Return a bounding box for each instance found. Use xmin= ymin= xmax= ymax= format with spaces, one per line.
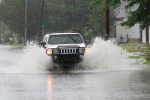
xmin=112 ymin=2 xmax=145 ymax=43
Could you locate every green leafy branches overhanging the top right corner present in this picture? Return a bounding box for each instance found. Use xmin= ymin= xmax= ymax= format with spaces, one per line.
xmin=90 ymin=0 xmax=150 ymax=30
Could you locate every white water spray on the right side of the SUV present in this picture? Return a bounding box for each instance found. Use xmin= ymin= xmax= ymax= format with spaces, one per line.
xmin=82 ymin=38 xmax=130 ymax=70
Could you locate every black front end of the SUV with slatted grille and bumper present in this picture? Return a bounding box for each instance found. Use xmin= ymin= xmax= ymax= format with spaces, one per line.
xmin=51 ymin=47 xmax=85 ymax=65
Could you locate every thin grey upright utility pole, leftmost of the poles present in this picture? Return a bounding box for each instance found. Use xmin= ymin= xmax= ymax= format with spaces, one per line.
xmin=24 ymin=0 xmax=27 ymax=46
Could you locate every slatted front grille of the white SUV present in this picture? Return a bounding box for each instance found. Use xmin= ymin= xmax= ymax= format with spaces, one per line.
xmin=59 ymin=48 xmax=78 ymax=54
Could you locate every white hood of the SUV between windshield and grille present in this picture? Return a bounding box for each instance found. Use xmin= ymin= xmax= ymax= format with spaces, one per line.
xmin=46 ymin=43 xmax=85 ymax=48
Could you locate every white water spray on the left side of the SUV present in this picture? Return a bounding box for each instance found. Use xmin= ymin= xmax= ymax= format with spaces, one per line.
xmin=17 ymin=43 xmax=52 ymax=72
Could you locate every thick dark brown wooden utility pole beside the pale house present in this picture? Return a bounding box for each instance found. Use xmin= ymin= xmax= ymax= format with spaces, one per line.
xmin=104 ymin=0 xmax=109 ymax=40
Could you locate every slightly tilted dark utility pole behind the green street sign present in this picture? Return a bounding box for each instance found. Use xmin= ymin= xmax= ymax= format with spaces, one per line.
xmin=38 ymin=0 xmax=44 ymax=44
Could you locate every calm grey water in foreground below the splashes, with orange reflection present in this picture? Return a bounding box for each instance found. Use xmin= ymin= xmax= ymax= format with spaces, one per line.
xmin=0 ymin=70 xmax=150 ymax=100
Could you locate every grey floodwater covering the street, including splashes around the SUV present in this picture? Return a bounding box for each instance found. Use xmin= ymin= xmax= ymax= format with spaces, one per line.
xmin=0 ymin=40 xmax=150 ymax=100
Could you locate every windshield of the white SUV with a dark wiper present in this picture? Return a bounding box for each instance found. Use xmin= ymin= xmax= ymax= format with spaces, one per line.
xmin=49 ymin=34 xmax=82 ymax=44
